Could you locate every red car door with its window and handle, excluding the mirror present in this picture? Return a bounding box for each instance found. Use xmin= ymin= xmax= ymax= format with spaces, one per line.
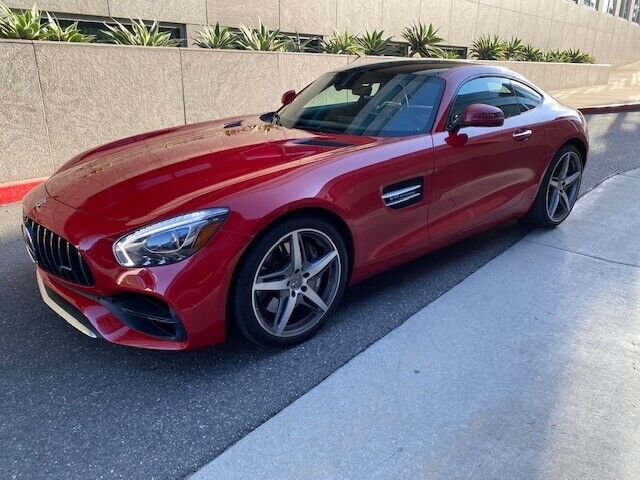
xmin=428 ymin=76 xmax=544 ymax=241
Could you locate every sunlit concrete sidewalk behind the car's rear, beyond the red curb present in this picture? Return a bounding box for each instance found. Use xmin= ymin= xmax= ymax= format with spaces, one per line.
xmin=549 ymin=62 xmax=640 ymax=108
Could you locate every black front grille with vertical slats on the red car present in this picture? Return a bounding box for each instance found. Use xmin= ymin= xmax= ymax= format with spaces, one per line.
xmin=24 ymin=218 xmax=93 ymax=287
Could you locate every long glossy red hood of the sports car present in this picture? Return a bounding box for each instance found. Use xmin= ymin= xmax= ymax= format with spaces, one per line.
xmin=45 ymin=117 xmax=374 ymax=224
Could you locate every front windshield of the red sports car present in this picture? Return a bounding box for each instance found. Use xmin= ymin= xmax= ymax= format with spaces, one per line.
xmin=274 ymin=69 xmax=444 ymax=137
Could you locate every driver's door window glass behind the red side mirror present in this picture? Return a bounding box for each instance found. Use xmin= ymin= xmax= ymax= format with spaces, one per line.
xmin=449 ymin=77 xmax=522 ymax=125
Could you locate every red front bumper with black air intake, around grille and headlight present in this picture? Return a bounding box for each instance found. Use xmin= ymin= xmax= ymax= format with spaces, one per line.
xmin=24 ymin=184 xmax=251 ymax=350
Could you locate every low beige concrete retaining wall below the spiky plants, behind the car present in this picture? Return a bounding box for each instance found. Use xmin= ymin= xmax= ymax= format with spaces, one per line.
xmin=0 ymin=40 xmax=610 ymax=182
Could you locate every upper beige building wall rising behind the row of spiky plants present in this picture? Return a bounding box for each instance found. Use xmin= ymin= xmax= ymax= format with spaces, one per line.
xmin=5 ymin=0 xmax=640 ymax=65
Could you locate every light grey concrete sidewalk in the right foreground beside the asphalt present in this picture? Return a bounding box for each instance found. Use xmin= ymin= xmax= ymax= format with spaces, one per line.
xmin=192 ymin=170 xmax=640 ymax=480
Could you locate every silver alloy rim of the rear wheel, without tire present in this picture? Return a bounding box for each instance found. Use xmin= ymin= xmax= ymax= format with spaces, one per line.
xmin=547 ymin=152 xmax=582 ymax=222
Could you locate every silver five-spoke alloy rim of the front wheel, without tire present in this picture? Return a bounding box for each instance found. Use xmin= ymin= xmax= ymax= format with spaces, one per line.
xmin=252 ymin=228 xmax=342 ymax=337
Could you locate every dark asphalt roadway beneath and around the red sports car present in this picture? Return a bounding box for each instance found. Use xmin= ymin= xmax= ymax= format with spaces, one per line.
xmin=0 ymin=113 xmax=640 ymax=479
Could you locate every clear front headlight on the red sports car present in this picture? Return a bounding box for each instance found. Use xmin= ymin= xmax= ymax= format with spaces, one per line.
xmin=113 ymin=208 xmax=229 ymax=267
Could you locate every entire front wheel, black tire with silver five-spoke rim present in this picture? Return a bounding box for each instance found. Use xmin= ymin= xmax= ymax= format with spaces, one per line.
xmin=230 ymin=217 xmax=349 ymax=347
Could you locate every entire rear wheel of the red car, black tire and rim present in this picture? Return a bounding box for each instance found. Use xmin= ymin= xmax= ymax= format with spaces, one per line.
xmin=525 ymin=145 xmax=584 ymax=228
